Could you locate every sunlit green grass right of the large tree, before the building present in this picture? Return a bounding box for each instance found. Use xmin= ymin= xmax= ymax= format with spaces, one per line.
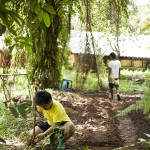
xmin=62 ymin=70 xmax=150 ymax=92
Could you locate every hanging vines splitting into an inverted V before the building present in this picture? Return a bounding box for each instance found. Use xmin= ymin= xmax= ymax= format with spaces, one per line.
xmin=76 ymin=0 xmax=104 ymax=89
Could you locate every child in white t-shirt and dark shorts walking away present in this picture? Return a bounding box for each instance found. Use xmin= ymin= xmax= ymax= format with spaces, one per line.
xmin=108 ymin=52 xmax=121 ymax=101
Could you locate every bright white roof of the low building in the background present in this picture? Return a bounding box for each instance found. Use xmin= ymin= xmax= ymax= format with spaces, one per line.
xmin=69 ymin=30 xmax=150 ymax=58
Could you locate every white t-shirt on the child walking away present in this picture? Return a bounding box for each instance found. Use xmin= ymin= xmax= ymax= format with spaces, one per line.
xmin=108 ymin=60 xmax=121 ymax=78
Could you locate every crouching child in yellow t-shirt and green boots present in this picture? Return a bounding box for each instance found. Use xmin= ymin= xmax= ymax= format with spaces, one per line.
xmin=29 ymin=91 xmax=75 ymax=149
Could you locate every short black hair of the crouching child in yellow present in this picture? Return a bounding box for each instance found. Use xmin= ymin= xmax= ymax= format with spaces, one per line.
xmin=34 ymin=91 xmax=52 ymax=105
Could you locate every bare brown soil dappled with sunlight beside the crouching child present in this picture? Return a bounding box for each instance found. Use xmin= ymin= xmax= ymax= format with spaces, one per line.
xmin=1 ymin=89 xmax=150 ymax=150
